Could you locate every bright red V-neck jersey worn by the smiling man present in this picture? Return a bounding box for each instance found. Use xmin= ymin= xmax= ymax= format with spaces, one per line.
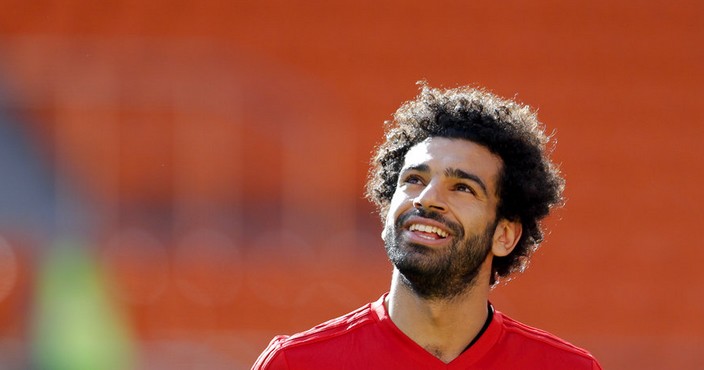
xmin=252 ymin=295 xmax=601 ymax=370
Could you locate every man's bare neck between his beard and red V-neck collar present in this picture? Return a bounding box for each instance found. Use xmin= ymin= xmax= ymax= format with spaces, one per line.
xmin=386 ymin=269 xmax=489 ymax=363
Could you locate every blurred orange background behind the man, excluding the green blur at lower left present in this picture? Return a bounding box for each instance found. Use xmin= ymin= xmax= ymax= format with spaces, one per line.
xmin=0 ymin=0 xmax=704 ymax=369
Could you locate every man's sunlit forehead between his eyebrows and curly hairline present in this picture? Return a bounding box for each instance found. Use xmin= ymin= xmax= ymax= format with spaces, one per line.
xmin=403 ymin=137 xmax=503 ymax=190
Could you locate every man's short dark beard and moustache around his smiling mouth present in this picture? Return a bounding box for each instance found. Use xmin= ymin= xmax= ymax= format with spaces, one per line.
xmin=384 ymin=208 xmax=496 ymax=300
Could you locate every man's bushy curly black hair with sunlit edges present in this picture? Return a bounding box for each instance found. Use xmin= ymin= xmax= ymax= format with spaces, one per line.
xmin=366 ymin=81 xmax=564 ymax=285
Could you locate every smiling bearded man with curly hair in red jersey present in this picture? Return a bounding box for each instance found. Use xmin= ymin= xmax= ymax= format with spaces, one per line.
xmin=253 ymin=84 xmax=601 ymax=370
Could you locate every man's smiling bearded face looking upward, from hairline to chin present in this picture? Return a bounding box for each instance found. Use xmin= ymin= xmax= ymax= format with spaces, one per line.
xmin=383 ymin=137 xmax=502 ymax=299
